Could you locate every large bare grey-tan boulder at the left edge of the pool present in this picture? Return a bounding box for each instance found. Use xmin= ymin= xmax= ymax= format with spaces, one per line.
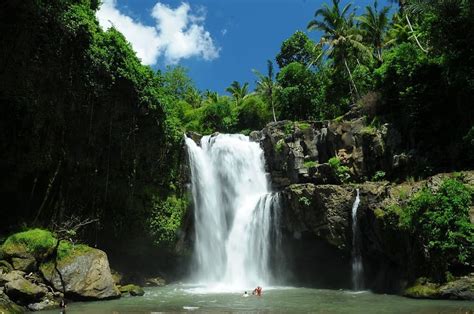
xmin=40 ymin=248 xmax=120 ymax=299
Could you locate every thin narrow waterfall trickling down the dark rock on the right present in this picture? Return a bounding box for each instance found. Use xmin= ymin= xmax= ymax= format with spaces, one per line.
xmin=352 ymin=189 xmax=364 ymax=291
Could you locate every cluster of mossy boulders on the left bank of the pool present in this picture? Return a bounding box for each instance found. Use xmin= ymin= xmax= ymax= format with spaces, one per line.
xmin=0 ymin=229 xmax=150 ymax=313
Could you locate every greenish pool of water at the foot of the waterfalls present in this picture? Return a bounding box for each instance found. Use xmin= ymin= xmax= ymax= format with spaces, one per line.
xmin=39 ymin=284 xmax=474 ymax=314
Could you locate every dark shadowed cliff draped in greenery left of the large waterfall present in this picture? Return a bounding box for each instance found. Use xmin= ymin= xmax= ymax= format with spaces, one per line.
xmin=0 ymin=0 xmax=189 ymax=254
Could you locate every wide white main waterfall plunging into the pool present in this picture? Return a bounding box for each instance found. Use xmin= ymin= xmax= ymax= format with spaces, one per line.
xmin=186 ymin=134 xmax=281 ymax=290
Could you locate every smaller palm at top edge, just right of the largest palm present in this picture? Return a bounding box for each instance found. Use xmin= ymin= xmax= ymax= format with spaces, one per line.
xmin=357 ymin=0 xmax=390 ymax=62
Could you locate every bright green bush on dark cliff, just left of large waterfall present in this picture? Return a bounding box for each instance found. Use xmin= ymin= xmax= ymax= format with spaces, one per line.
xmin=149 ymin=195 xmax=188 ymax=246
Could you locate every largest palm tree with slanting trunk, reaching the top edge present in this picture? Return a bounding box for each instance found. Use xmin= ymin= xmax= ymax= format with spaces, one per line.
xmin=307 ymin=0 xmax=372 ymax=98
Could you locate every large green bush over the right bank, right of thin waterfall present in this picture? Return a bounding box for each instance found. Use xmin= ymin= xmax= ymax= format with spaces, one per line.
xmin=400 ymin=178 xmax=474 ymax=280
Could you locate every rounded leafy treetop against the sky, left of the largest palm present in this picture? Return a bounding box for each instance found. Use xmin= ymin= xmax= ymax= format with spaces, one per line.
xmin=276 ymin=31 xmax=321 ymax=68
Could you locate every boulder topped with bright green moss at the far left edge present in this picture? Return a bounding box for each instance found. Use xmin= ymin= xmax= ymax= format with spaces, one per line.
xmin=0 ymin=229 xmax=56 ymax=261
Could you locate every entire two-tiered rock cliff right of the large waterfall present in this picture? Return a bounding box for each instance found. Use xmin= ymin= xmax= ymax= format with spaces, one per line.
xmin=250 ymin=118 xmax=474 ymax=298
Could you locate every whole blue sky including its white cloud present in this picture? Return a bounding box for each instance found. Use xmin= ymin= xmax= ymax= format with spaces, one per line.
xmin=96 ymin=0 xmax=388 ymax=94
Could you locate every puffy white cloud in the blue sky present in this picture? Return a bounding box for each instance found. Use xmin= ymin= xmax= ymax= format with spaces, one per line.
xmin=97 ymin=0 xmax=220 ymax=65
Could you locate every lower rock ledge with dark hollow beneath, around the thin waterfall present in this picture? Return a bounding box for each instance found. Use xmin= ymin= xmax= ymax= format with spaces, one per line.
xmin=280 ymin=171 xmax=474 ymax=294
